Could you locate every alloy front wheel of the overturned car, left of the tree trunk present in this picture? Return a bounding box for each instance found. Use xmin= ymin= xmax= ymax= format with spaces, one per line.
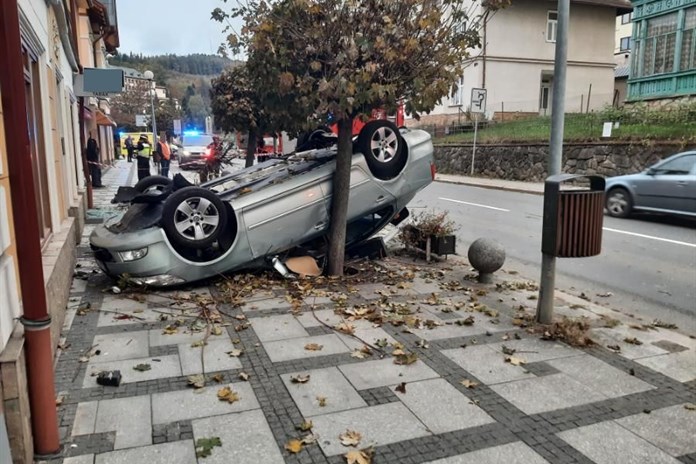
xmin=162 ymin=187 xmax=227 ymax=249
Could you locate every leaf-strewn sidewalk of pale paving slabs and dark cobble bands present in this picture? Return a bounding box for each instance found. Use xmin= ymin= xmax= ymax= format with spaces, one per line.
xmin=47 ymin=162 xmax=696 ymax=464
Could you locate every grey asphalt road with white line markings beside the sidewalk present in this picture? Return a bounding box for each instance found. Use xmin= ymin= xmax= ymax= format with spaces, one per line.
xmin=409 ymin=182 xmax=696 ymax=335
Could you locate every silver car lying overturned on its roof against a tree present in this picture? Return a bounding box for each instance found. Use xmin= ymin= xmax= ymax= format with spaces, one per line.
xmin=90 ymin=120 xmax=435 ymax=286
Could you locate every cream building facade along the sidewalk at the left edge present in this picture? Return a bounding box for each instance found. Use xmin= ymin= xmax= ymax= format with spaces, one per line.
xmin=0 ymin=0 xmax=118 ymax=464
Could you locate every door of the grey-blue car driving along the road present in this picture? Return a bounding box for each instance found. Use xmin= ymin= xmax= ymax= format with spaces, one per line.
xmin=635 ymin=152 xmax=696 ymax=213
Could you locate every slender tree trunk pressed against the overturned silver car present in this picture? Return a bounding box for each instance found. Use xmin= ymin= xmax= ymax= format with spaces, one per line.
xmin=328 ymin=116 xmax=353 ymax=276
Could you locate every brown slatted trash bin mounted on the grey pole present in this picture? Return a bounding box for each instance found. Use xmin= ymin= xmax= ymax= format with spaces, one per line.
xmin=541 ymin=174 xmax=605 ymax=258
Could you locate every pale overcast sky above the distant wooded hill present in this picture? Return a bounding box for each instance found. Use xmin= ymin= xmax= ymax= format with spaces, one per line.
xmin=116 ymin=0 xmax=235 ymax=55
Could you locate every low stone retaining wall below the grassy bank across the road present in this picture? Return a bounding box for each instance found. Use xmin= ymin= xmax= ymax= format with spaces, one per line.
xmin=435 ymin=143 xmax=688 ymax=182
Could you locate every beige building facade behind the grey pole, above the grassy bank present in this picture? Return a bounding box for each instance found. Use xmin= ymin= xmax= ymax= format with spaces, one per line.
xmin=422 ymin=0 xmax=631 ymax=124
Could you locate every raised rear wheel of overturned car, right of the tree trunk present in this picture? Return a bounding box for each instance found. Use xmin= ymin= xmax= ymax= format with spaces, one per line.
xmin=356 ymin=119 xmax=406 ymax=180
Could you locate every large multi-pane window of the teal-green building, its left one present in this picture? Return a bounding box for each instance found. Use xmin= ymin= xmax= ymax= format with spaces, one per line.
xmin=640 ymin=13 xmax=677 ymax=76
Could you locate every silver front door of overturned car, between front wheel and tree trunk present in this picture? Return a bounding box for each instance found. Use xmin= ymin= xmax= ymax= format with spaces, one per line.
xmin=244 ymin=166 xmax=332 ymax=258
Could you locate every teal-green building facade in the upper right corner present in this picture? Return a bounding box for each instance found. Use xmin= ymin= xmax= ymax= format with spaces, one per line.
xmin=628 ymin=0 xmax=696 ymax=102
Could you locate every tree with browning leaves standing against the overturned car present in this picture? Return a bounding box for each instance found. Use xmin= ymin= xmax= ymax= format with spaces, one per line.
xmin=213 ymin=0 xmax=509 ymax=275
